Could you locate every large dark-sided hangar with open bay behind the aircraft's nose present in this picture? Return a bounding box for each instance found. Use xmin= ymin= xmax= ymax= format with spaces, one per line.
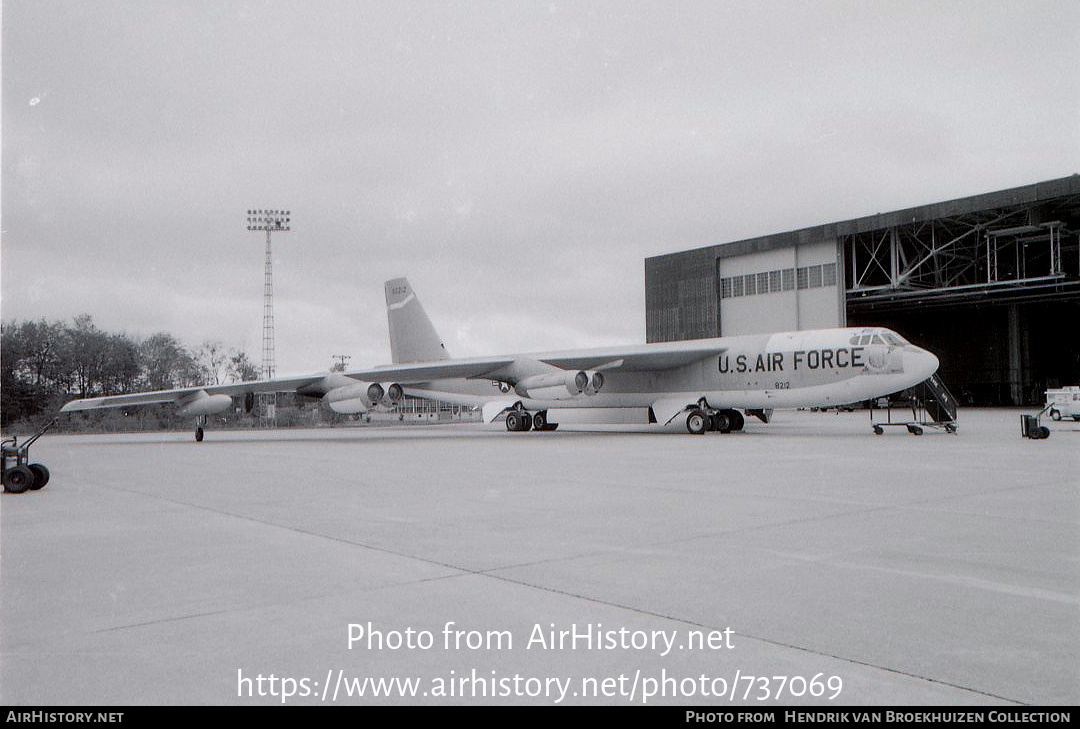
xmin=645 ymin=175 xmax=1080 ymax=405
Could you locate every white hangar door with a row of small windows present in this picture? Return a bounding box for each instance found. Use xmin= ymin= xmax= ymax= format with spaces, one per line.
xmin=716 ymin=240 xmax=847 ymax=336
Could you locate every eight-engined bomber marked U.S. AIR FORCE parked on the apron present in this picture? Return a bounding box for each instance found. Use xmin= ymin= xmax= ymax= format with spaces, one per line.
xmin=62 ymin=279 xmax=937 ymax=441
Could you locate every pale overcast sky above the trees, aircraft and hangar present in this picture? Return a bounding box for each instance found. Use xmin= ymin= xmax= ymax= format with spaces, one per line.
xmin=0 ymin=0 xmax=1080 ymax=374
